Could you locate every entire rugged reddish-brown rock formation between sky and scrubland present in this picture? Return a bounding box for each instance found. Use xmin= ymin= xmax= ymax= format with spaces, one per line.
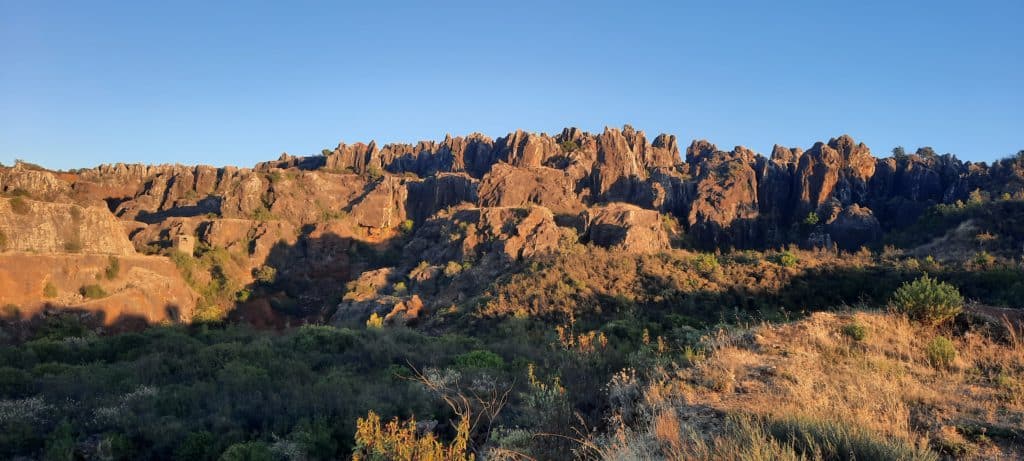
xmin=0 ymin=125 xmax=1024 ymax=323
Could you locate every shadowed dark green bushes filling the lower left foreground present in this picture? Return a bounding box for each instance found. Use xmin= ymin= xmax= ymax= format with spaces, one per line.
xmin=0 ymin=325 xmax=499 ymax=460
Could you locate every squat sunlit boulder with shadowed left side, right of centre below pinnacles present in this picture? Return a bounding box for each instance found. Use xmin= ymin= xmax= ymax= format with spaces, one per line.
xmin=585 ymin=203 xmax=670 ymax=253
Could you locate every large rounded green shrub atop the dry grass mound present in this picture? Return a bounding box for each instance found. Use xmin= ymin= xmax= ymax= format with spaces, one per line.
xmin=890 ymin=275 xmax=964 ymax=325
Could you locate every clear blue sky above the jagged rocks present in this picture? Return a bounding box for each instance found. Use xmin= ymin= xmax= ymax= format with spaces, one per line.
xmin=0 ymin=0 xmax=1024 ymax=168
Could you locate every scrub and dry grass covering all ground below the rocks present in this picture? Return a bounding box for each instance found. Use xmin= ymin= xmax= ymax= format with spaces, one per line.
xmin=0 ymin=235 xmax=1024 ymax=459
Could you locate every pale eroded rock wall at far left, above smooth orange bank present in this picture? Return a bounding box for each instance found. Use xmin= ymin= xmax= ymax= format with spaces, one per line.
xmin=0 ymin=198 xmax=135 ymax=255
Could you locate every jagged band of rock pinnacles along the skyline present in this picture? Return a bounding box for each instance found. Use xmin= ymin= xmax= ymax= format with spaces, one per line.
xmin=0 ymin=125 xmax=1015 ymax=254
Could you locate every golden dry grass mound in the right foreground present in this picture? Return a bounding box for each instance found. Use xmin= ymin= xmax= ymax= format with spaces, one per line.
xmin=605 ymin=312 xmax=1024 ymax=459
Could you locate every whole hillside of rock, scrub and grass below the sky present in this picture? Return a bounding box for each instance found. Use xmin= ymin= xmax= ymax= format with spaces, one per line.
xmin=0 ymin=126 xmax=1024 ymax=459
